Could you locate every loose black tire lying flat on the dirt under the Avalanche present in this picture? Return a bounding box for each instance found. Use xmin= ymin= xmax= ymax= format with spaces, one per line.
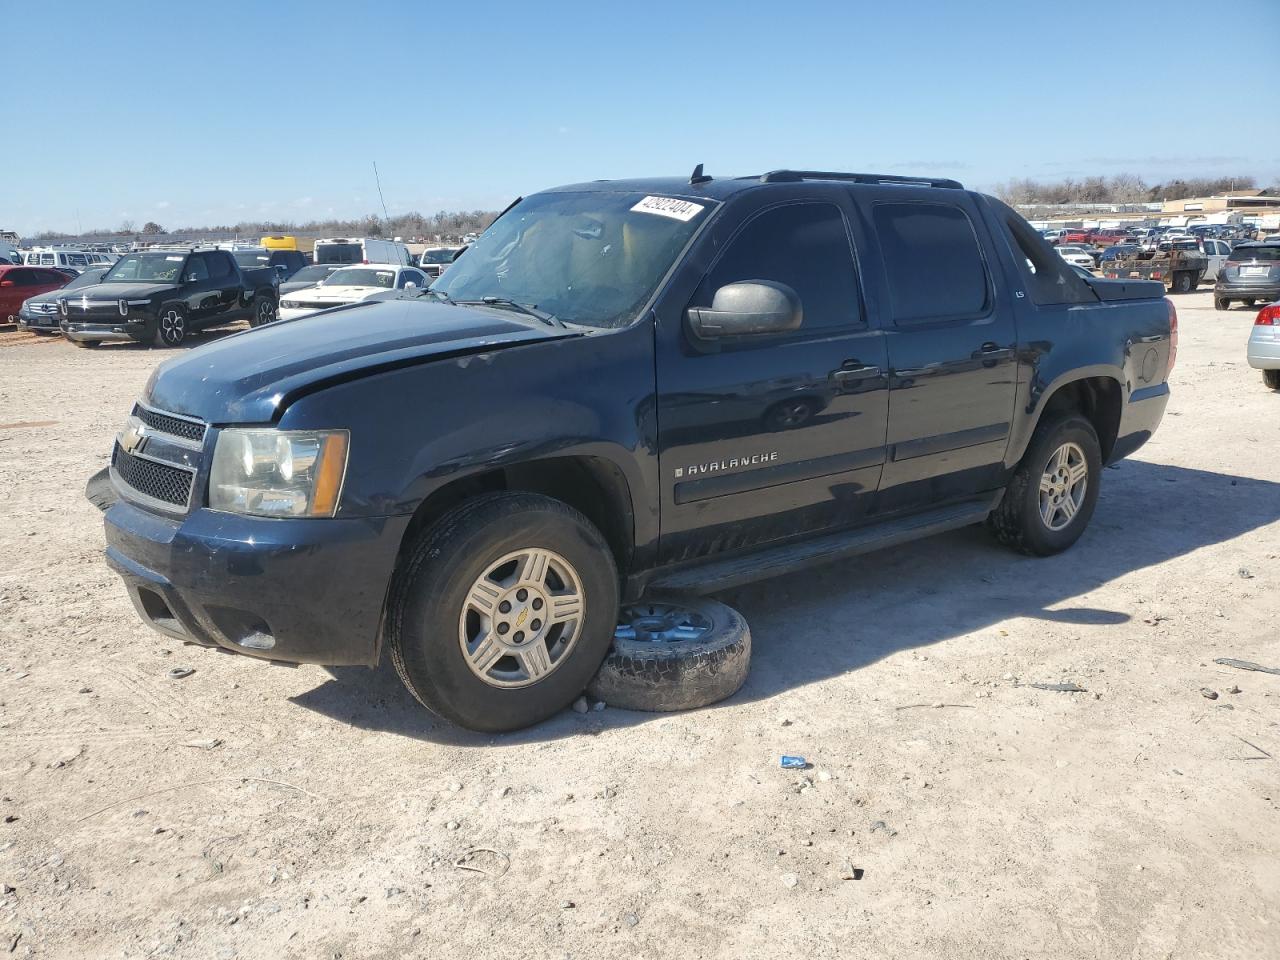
xmin=588 ymin=596 xmax=751 ymax=713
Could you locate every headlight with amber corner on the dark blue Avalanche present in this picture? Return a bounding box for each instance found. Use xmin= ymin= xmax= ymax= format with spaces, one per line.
xmin=209 ymin=429 xmax=351 ymax=517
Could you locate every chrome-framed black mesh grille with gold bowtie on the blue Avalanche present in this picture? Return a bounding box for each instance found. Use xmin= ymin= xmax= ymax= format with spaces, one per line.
xmin=111 ymin=403 xmax=209 ymax=513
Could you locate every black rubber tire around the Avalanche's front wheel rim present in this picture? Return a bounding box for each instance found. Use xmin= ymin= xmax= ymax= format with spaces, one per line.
xmin=387 ymin=493 xmax=618 ymax=732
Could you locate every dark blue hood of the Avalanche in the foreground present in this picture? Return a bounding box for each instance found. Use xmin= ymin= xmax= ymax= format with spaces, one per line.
xmin=143 ymin=300 xmax=582 ymax=424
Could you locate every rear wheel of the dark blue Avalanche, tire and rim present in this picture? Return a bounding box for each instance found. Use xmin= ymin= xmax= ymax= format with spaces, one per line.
xmin=987 ymin=412 xmax=1102 ymax=557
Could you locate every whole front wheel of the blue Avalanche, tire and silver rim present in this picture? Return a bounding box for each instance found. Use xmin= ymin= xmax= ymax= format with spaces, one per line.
xmin=387 ymin=493 xmax=618 ymax=732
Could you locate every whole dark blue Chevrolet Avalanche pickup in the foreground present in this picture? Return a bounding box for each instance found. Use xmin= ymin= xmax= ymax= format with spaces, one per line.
xmin=105 ymin=169 xmax=1176 ymax=731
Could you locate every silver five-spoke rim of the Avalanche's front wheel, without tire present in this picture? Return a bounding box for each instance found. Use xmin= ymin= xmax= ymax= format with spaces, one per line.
xmin=458 ymin=548 xmax=586 ymax=687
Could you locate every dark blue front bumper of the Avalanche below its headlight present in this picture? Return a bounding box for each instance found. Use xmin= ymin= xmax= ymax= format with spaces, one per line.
xmin=104 ymin=500 xmax=410 ymax=666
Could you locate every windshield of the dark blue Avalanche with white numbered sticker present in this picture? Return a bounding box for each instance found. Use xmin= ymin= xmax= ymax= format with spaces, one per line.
xmin=431 ymin=192 xmax=713 ymax=326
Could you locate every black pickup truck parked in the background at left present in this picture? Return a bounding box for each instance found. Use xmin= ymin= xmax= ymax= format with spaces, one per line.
xmin=58 ymin=248 xmax=279 ymax=347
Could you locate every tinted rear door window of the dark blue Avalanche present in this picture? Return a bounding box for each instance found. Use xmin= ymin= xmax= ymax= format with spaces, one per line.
xmin=872 ymin=204 xmax=991 ymax=324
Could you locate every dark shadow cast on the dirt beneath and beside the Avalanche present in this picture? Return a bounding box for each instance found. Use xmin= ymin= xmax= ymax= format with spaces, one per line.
xmin=293 ymin=461 xmax=1280 ymax=746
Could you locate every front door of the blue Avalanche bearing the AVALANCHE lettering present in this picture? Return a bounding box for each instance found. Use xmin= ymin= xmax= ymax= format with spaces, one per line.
xmin=657 ymin=191 xmax=887 ymax=562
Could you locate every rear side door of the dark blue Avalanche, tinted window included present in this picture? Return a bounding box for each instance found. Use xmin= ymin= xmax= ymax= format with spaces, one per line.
xmin=855 ymin=187 xmax=1018 ymax=511
